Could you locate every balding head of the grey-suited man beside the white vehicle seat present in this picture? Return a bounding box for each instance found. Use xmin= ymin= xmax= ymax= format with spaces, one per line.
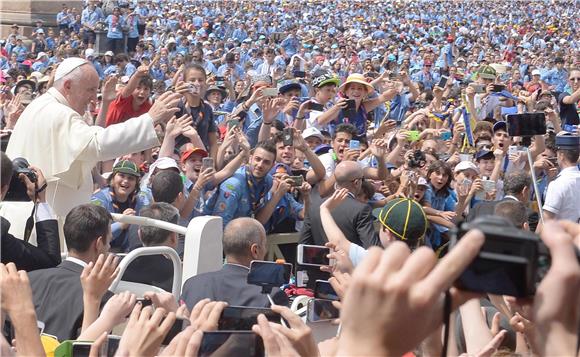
xmin=223 ymin=217 xmax=266 ymax=261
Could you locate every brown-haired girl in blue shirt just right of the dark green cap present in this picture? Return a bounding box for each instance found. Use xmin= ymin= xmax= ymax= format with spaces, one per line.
xmin=423 ymin=161 xmax=457 ymax=250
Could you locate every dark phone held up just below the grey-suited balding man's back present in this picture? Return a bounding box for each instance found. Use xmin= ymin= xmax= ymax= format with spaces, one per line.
xmin=218 ymin=306 xmax=281 ymax=331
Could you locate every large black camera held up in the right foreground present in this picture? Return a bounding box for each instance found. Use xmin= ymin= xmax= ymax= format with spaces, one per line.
xmin=450 ymin=216 xmax=551 ymax=297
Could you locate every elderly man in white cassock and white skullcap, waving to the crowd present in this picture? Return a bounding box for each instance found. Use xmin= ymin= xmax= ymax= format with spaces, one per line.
xmin=6 ymin=57 xmax=181 ymax=218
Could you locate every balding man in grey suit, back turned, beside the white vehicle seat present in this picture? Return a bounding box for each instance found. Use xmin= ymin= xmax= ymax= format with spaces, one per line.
xmin=181 ymin=218 xmax=288 ymax=310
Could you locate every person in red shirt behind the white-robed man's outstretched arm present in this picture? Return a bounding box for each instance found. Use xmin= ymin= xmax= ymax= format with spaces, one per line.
xmin=106 ymin=66 xmax=153 ymax=126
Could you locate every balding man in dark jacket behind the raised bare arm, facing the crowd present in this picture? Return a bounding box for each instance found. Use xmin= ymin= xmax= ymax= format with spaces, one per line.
xmin=300 ymin=161 xmax=380 ymax=249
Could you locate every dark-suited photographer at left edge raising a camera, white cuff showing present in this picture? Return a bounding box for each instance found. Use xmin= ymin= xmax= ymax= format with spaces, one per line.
xmin=0 ymin=152 xmax=60 ymax=271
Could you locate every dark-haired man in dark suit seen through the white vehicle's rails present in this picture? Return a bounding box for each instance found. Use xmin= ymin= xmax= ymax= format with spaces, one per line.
xmin=122 ymin=202 xmax=179 ymax=292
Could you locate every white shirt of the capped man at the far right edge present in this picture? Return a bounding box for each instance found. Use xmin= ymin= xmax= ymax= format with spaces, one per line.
xmin=543 ymin=166 xmax=580 ymax=223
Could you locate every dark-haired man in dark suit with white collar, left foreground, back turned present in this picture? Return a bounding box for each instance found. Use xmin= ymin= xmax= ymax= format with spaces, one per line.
xmin=29 ymin=204 xmax=112 ymax=341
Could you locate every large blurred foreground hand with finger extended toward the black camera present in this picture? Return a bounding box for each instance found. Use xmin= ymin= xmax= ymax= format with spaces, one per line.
xmin=338 ymin=230 xmax=484 ymax=356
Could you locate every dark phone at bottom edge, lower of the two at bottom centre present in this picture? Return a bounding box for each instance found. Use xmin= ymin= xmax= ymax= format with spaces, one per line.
xmin=198 ymin=331 xmax=264 ymax=357
